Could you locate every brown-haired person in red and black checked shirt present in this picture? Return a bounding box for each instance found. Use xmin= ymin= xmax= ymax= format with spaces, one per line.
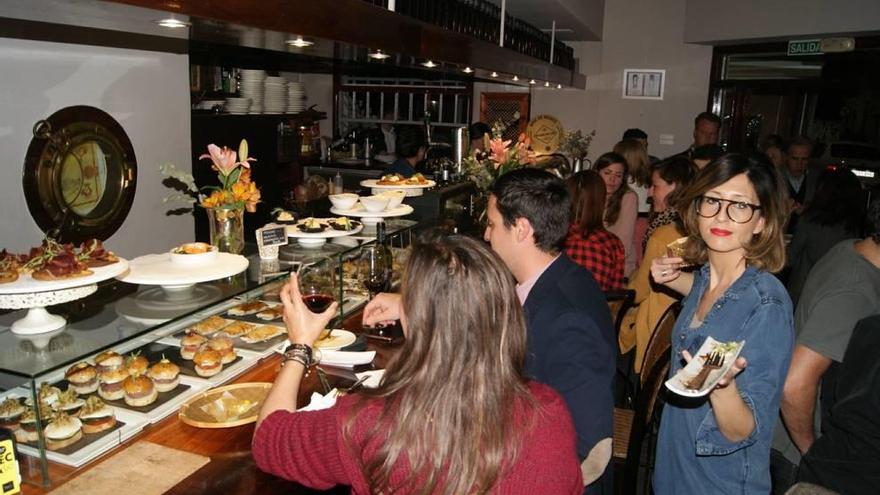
xmin=565 ymin=170 xmax=626 ymax=291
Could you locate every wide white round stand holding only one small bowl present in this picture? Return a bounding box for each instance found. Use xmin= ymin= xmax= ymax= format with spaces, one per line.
xmin=117 ymin=253 xmax=248 ymax=287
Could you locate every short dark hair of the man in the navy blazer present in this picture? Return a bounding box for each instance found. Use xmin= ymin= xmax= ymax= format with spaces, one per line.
xmin=489 ymin=168 xmax=571 ymax=253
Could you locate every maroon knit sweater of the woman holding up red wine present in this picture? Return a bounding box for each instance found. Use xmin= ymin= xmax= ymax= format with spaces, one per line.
xmin=253 ymin=382 xmax=584 ymax=495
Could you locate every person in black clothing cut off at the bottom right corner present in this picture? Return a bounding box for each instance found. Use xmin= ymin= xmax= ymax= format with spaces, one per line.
xmin=798 ymin=315 xmax=880 ymax=495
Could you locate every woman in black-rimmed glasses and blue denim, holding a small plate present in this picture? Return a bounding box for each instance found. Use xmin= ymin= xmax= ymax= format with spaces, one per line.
xmin=651 ymin=154 xmax=794 ymax=494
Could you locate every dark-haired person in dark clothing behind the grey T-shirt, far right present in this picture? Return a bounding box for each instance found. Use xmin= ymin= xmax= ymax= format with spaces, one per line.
xmin=786 ymin=168 xmax=865 ymax=307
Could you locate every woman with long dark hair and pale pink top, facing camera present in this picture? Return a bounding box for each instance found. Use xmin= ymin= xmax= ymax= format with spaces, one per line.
xmin=593 ymin=152 xmax=638 ymax=275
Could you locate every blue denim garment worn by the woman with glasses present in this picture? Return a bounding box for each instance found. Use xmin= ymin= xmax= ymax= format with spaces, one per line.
xmin=654 ymin=264 xmax=794 ymax=494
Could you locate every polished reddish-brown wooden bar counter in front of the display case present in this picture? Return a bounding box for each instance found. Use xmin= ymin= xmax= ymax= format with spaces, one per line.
xmin=21 ymin=311 xmax=400 ymax=495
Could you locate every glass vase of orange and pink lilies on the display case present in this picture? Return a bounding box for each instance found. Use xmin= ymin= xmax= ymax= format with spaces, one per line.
xmin=160 ymin=139 xmax=260 ymax=254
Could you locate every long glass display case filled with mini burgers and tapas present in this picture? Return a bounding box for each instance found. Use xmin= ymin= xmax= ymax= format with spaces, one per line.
xmin=0 ymin=220 xmax=418 ymax=486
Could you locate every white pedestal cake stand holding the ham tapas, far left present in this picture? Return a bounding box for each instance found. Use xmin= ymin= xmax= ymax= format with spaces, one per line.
xmin=0 ymin=259 xmax=128 ymax=335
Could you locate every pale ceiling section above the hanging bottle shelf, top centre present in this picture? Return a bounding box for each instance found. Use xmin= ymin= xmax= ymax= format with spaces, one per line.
xmin=490 ymin=0 xmax=605 ymax=41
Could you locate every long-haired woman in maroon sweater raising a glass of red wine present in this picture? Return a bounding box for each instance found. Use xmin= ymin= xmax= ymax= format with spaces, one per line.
xmin=253 ymin=236 xmax=583 ymax=495
